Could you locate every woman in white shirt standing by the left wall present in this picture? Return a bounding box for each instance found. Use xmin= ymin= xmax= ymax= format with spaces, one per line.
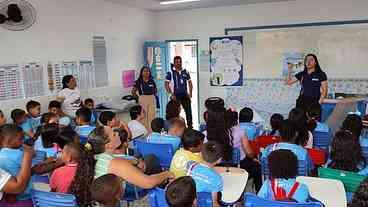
xmin=57 ymin=75 xmax=82 ymax=117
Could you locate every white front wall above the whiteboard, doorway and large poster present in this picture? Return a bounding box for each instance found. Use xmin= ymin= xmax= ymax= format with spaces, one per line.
xmin=157 ymin=0 xmax=368 ymax=118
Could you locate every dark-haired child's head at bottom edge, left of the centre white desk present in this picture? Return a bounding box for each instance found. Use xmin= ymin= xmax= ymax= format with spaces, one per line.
xmin=165 ymin=176 xmax=197 ymax=207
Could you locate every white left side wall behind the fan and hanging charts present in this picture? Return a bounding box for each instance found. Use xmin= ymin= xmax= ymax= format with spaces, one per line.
xmin=0 ymin=0 xmax=156 ymax=114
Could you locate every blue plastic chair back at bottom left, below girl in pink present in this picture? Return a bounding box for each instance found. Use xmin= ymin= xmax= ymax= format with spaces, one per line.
xmin=31 ymin=190 xmax=78 ymax=207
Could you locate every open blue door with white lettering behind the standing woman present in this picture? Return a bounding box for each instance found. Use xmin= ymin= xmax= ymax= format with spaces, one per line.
xmin=143 ymin=42 xmax=169 ymax=119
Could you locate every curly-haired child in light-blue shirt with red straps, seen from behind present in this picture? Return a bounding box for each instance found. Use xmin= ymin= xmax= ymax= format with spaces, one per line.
xmin=258 ymin=149 xmax=309 ymax=203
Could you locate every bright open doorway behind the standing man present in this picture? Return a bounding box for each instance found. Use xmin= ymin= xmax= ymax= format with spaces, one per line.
xmin=168 ymin=40 xmax=199 ymax=129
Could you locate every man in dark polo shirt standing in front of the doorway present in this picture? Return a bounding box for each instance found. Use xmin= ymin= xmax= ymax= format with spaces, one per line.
xmin=165 ymin=56 xmax=193 ymax=128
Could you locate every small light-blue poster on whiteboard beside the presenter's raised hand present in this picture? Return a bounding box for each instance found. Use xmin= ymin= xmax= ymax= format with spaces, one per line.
xmin=282 ymin=52 xmax=305 ymax=78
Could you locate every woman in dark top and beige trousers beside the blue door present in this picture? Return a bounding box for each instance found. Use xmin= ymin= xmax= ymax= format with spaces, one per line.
xmin=132 ymin=66 xmax=157 ymax=130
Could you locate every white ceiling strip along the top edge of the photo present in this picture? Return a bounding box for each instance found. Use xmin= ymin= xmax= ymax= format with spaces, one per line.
xmin=105 ymin=0 xmax=295 ymax=11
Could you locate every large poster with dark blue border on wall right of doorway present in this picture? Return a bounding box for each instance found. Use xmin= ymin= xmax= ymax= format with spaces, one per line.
xmin=210 ymin=36 xmax=244 ymax=86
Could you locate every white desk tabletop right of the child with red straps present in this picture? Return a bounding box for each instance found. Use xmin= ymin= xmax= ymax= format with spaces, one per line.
xmin=296 ymin=176 xmax=347 ymax=207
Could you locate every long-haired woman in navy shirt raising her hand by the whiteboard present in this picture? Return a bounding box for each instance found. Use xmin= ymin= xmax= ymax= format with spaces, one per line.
xmin=286 ymin=54 xmax=328 ymax=111
